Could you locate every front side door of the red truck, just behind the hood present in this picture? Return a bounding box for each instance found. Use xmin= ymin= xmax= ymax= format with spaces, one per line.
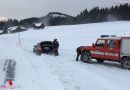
xmin=91 ymin=39 xmax=105 ymax=59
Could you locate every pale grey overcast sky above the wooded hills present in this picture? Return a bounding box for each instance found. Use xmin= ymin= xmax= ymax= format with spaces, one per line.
xmin=0 ymin=0 xmax=130 ymax=19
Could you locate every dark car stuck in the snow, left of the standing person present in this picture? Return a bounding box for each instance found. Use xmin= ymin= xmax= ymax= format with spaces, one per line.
xmin=33 ymin=41 xmax=55 ymax=55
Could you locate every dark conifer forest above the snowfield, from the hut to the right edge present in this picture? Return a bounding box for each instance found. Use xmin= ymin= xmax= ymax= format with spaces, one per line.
xmin=50 ymin=4 xmax=130 ymax=25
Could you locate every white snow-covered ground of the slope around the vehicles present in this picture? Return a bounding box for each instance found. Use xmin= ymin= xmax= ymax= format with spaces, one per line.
xmin=0 ymin=21 xmax=130 ymax=90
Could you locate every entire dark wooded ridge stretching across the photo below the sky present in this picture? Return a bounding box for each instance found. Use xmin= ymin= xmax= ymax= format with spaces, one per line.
xmin=0 ymin=4 xmax=130 ymax=29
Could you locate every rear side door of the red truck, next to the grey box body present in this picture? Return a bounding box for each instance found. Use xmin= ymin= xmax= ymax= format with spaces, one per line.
xmin=105 ymin=40 xmax=120 ymax=60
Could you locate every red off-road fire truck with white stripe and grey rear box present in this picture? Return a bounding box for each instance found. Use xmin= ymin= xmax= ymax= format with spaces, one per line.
xmin=80 ymin=37 xmax=130 ymax=69
